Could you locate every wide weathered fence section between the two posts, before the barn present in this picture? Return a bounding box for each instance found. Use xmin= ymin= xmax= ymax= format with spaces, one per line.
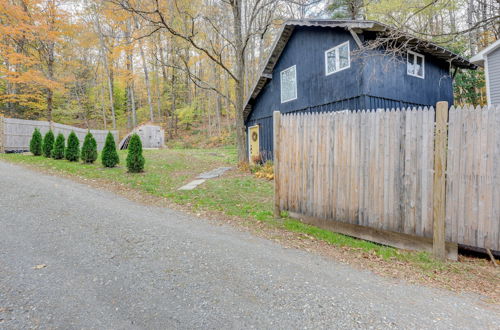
xmin=278 ymin=109 xmax=434 ymax=237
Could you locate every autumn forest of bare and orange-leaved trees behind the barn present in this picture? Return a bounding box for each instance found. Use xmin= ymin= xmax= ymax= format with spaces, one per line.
xmin=0 ymin=0 xmax=500 ymax=160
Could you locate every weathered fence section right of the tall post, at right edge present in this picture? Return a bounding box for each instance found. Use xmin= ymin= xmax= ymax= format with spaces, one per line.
xmin=446 ymin=107 xmax=500 ymax=251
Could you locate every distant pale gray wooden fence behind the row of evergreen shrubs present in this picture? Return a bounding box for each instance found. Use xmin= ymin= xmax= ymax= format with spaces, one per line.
xmin=0 ymin=116 xmax=118 ymax=152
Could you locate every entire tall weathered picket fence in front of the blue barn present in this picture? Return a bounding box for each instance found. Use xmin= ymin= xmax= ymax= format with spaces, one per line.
xmin=274 ymin=104 xmax=500 ymax=256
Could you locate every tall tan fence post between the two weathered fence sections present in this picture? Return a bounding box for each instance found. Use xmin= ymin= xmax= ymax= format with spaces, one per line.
xmin=432 ymin=101 xmax=448 ymax=260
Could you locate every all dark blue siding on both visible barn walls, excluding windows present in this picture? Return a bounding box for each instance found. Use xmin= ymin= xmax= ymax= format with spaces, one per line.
xmin=247 ymin=27 xmax=453 ymax=160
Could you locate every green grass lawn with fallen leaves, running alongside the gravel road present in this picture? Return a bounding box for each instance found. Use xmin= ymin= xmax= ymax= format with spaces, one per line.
xmin=0 ymin=148 xmax=498 ymax=300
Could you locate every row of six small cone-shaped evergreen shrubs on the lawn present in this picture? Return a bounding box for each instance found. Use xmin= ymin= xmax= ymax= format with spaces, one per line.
xmin=30 ymin=128 xmax=145 ymax=173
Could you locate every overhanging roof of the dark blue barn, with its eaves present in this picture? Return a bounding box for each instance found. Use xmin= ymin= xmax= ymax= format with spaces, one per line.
xmin=243 ymin=19 xmax=477 ymax=120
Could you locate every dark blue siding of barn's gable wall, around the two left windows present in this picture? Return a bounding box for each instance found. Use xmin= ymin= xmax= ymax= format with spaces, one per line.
xmin=249 ymin=28 xmax=363 ymax=119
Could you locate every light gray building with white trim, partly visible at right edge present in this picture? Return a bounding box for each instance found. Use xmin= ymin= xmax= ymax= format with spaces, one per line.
xmin=470 ymin=40 xmax=500 ymax=105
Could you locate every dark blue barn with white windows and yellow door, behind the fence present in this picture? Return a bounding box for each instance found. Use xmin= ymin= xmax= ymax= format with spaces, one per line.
xmin=244 ymin=20 xmax=476 ymax=160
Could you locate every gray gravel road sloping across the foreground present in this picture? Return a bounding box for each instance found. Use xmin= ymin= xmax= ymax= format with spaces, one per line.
xmin=0 ymin=162 xmax=500 ymax=329
